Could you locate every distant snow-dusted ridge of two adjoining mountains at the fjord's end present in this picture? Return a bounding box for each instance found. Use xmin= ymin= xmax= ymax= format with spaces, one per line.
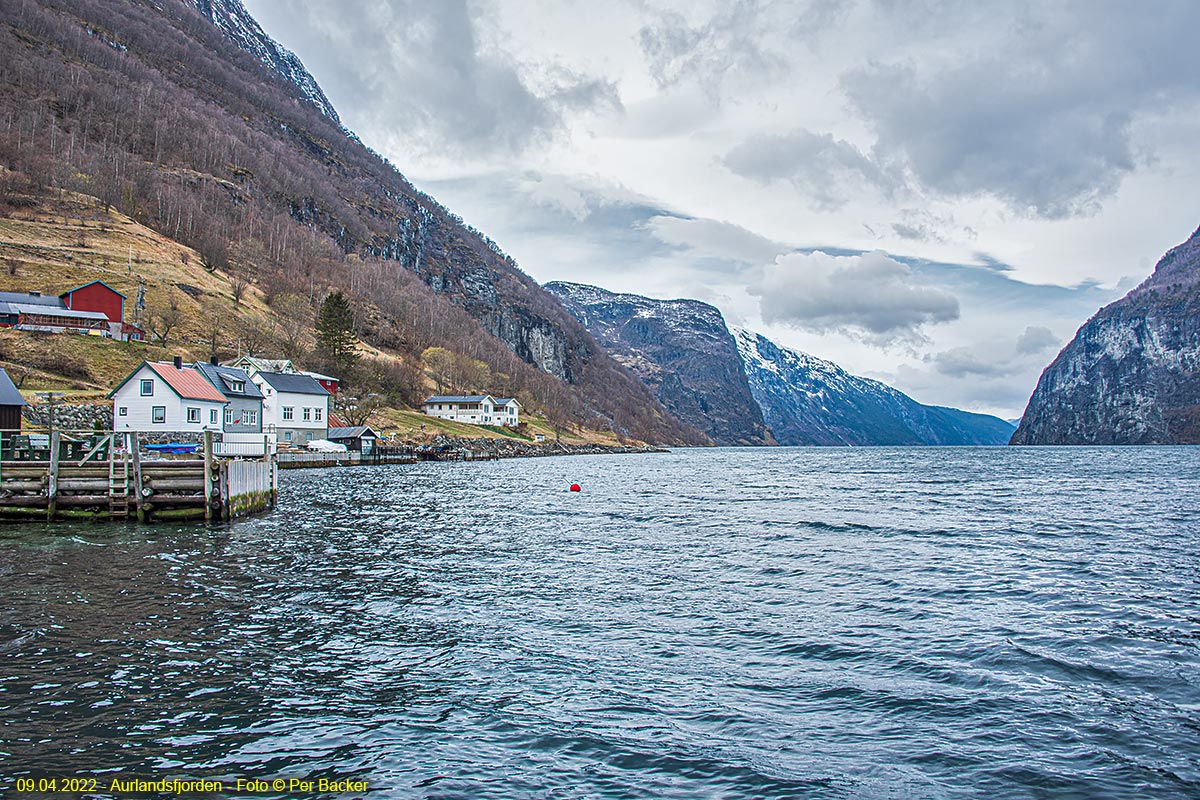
xmin=544 ymin=282 xmax=1014 ymax=446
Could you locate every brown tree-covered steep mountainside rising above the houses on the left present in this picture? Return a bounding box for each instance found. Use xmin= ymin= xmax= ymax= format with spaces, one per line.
xmin=0 ymin=0 xmax=695 ymax=441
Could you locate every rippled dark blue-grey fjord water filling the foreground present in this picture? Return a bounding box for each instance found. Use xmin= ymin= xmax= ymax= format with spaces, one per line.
xmin=0 ymin=449 xmax=1200 ymax=798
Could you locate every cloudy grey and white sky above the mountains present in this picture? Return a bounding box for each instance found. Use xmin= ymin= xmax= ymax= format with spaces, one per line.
xmin=245 ymin=0 xmax=1200 ymax=419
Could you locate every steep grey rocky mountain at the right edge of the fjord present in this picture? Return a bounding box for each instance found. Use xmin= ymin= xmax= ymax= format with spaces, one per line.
xmin=1013 ymin=229 xmax=1200 ymax=445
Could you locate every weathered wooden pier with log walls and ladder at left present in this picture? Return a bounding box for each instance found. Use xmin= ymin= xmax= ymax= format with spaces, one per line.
xmin=0 ymin=432 xmax=278 ymax=522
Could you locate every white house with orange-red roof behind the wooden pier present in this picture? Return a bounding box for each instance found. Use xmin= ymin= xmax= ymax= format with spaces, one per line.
xmin=108 ymin=357 xmax=229 ymax=433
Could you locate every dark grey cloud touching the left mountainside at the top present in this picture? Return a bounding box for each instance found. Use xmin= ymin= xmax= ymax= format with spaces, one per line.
xmin=242 ymin=0 xmax=619 ymax=155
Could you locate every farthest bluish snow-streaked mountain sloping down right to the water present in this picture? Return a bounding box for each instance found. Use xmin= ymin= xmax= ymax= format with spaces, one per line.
xmin=734 ymin=330 xmax=1013 ymax=445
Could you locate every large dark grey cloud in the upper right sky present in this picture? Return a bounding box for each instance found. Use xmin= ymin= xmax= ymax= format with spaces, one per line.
xmin=841 ymin=1 xmax=1200 ymax=218
